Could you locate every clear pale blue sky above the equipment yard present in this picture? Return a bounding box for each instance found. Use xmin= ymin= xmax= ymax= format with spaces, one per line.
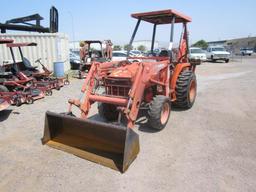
xmin=0 ymin=0 xmax=256 ymax=44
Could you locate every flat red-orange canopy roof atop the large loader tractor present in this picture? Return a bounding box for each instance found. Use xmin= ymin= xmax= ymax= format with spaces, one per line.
xmin=131 ymin=9 xmax=192 ymax=24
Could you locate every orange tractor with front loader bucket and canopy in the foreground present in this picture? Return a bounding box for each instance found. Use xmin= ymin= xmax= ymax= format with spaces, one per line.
xmin=42 ymin=10 xmax=197 ymax=172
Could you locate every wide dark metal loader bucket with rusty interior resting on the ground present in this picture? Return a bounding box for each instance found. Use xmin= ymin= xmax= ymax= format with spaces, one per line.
xmin=42 ymin=111 xmax=139 ymax=172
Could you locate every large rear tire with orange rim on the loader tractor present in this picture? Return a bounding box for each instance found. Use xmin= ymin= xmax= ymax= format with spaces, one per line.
xmin=174 ymin=71 xmax=197 ymax=109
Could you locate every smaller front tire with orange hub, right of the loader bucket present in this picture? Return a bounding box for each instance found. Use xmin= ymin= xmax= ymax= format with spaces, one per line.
xmin=148 ymin=95 xmax=171 ymax=130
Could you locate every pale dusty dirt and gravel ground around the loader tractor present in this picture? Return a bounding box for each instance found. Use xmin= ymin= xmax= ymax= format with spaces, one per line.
xmin=0 ymin=57 xmax=256 ymax=192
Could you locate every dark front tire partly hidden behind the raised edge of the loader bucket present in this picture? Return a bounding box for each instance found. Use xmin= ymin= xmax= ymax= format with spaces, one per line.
xmin=98 ymin=103 xmax=119 ymax=121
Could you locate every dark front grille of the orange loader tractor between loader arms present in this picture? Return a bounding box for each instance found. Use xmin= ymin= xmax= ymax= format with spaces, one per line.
xmin=105 ymin=78 xmax=132 ymax=97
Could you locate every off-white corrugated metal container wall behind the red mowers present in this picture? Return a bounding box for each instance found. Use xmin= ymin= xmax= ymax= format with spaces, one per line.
xmin=0 ymin=33 xmax=70 ymax=71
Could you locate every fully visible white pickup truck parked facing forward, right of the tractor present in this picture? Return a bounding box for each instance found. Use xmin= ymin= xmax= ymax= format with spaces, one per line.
xmin=206 ymin=46 xmax=230 ymax=63
